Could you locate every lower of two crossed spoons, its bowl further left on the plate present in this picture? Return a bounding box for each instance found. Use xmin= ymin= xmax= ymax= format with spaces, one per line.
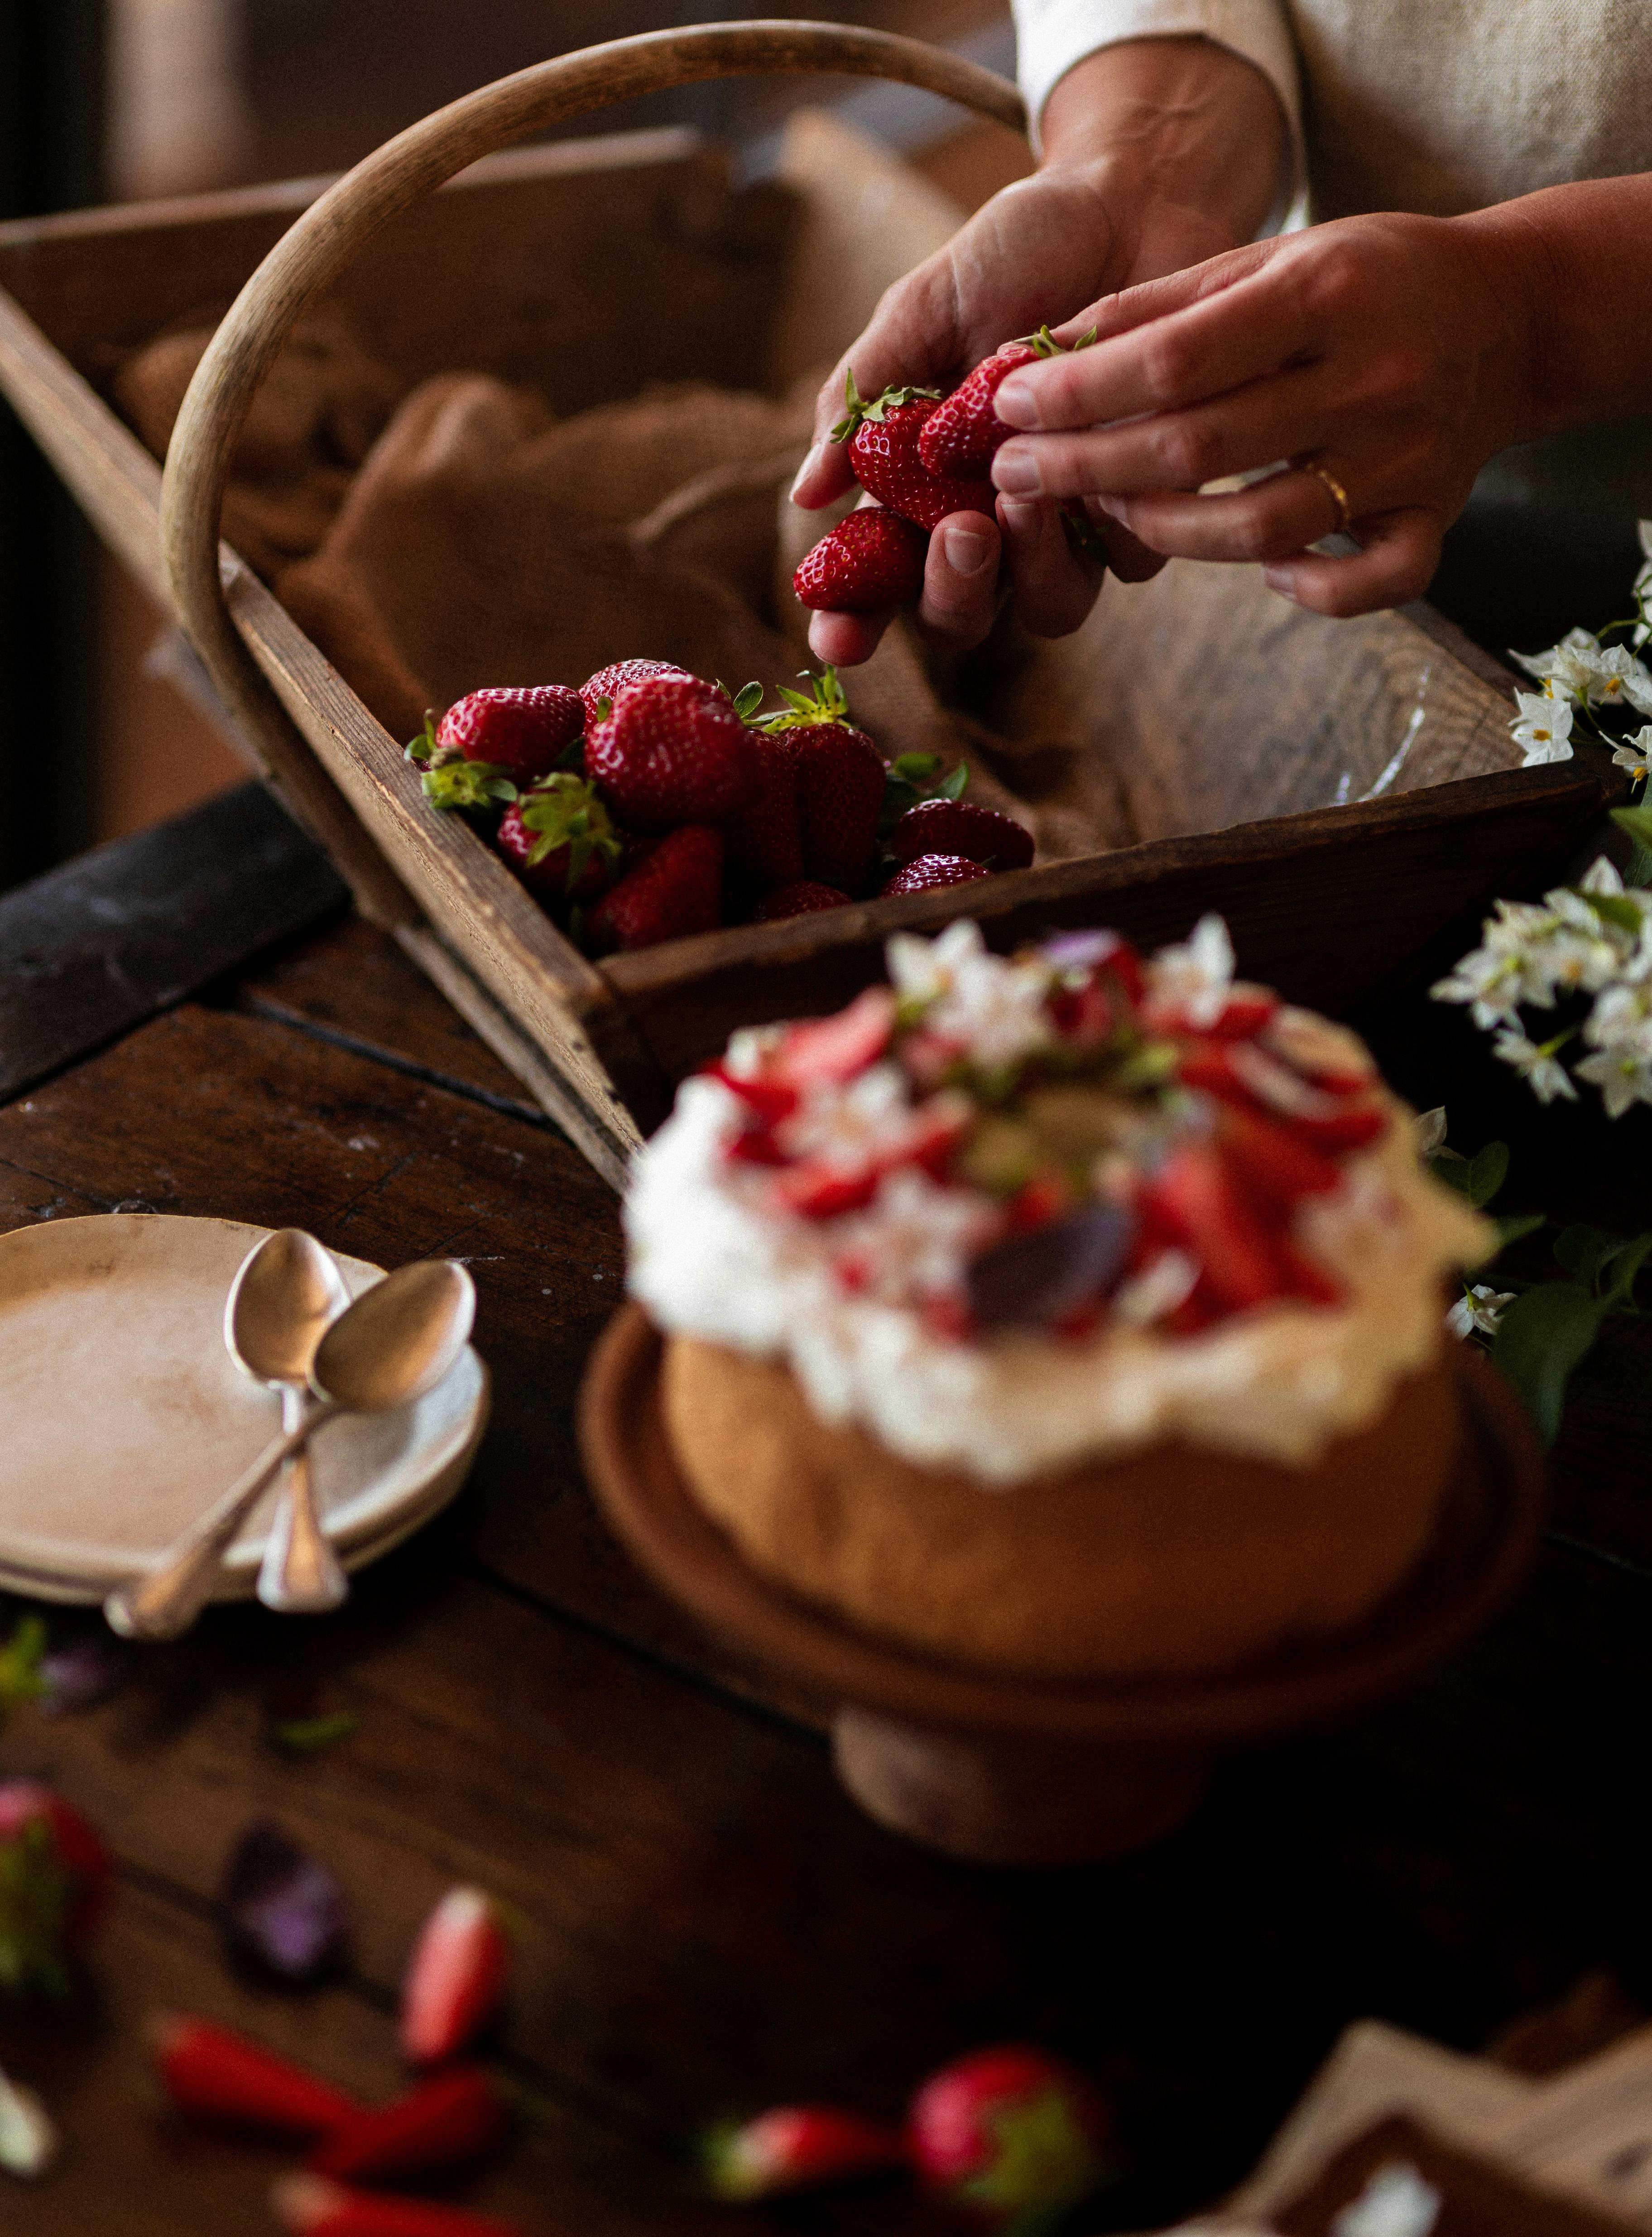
xmin=224 ymin=1228 xmax=351 ymax=1615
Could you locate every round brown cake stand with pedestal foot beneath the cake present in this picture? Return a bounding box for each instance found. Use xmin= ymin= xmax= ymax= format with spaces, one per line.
xmin=579 ymin=1304 xmax=1545 ymax=1866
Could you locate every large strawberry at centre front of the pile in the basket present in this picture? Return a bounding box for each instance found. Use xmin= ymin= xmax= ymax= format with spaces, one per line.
xmin=586 ymin=676 xmax=756 ymax=832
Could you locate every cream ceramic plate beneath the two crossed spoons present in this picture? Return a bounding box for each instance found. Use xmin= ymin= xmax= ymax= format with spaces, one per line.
xmin=0 ymin=1212 xmax=487 ymax=1599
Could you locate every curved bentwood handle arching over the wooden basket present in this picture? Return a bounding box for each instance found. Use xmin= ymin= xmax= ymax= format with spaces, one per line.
xmin=161 ymin=20 xmax=1026 ymax=792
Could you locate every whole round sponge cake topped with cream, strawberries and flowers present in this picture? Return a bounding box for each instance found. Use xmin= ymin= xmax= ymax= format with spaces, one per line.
xmin=626 ymin=917 xmax=1494 ymax=1680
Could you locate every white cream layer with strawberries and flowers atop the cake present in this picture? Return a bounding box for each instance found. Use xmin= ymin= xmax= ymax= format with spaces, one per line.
xmin=626 ymin=917 xmax=1491 ymax=1483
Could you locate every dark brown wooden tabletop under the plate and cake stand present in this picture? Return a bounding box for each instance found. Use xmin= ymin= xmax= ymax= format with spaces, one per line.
xmin=0 ymin=788 xmax=1652 ymax=2237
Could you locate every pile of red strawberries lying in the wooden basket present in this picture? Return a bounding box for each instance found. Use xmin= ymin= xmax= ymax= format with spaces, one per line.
xmin=407 ymin=660 xmax=1033 ymax=955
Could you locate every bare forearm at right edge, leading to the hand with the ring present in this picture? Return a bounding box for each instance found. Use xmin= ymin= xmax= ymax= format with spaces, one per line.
xmin=1453 ymin=172 xmax=1652 ymax=441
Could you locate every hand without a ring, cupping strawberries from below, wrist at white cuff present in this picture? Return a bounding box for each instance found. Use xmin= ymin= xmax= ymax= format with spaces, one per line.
xmin=791 ymin=38 xmax=1283 ymax=667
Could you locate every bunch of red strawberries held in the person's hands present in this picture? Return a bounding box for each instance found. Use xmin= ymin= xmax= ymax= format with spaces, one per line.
xmin=791 ymin=327 xmax=1107 ymax=613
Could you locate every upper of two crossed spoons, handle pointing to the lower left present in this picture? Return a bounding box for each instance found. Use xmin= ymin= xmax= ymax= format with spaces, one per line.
xmin=103 ymin=1260 xmax=476 ymax=1640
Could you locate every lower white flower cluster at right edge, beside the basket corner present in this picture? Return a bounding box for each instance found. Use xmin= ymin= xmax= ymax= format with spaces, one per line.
xmin=1433 ymin=857 xmax=1652 ymax=1119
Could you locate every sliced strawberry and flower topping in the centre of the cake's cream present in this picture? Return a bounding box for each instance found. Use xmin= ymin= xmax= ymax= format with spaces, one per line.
xmin=706 ymin=919 xmax=1390 ymax=1340
